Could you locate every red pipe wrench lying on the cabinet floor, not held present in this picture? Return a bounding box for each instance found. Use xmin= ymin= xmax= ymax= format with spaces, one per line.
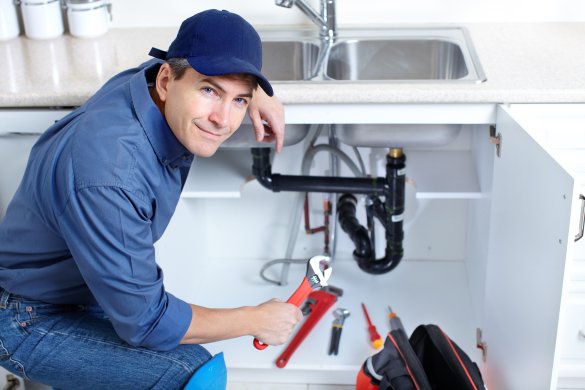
xmin=276 ymin=287 xmax=342 ymax=368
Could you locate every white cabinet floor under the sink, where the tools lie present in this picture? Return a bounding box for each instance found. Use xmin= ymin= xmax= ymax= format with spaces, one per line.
xmin=161 ymin=256 xmax=481 ymax=385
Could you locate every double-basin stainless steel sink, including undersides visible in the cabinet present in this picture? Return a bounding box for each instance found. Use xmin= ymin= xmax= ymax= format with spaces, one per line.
xmin=224 ymin=27 xmax=486 ymax=147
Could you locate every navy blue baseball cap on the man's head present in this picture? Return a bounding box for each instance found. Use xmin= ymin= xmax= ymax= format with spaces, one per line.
xmin=149 ymin=9 xmax=274 ymax=96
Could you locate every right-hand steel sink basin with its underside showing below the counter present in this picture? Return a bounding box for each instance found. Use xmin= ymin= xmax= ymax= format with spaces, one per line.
xmin=324 ymin=27 xmax=486 ymax=148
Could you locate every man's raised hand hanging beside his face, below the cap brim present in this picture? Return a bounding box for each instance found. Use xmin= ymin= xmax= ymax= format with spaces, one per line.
xmin=248 ymin=88 xmax=284 ymax=153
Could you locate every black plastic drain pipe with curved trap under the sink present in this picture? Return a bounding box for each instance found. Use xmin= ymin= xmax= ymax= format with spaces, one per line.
xmin=251 ymin=148 xmax=406 ymax=274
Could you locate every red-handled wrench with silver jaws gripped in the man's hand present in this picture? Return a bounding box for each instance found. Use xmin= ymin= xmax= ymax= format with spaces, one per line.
xmin=254 ymin=255 xmax=333 ymax=349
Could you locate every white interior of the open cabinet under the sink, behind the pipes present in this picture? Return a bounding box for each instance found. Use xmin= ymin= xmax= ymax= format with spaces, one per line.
xmin=152 ymin=125 xmax=495 ymax=384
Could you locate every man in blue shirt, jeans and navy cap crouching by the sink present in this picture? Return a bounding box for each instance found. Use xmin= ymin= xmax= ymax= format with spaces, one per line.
xmin=0 ymin=10 xmax=302 ymax=389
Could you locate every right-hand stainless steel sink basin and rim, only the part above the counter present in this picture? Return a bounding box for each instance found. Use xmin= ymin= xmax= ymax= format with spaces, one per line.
xmin=324 ymin=27 xmax=485 ymax=83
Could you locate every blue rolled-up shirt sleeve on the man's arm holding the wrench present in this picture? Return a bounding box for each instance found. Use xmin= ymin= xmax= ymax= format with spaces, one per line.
xmin=58 ymin=186 xmax=192 ymax=350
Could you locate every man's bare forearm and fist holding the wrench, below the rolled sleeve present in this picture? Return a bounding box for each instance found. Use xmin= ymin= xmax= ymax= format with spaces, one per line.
xmin=181 ymin=299 xmax=303 ymax=345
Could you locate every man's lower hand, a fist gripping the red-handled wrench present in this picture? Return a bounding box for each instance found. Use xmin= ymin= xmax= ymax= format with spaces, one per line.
xmin=253 ymin=299 xmax=303 ymax=345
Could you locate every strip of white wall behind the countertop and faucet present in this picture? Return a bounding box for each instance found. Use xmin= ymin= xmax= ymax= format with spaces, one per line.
xmin=112 ymin=0 xmax=585 ymax=27
